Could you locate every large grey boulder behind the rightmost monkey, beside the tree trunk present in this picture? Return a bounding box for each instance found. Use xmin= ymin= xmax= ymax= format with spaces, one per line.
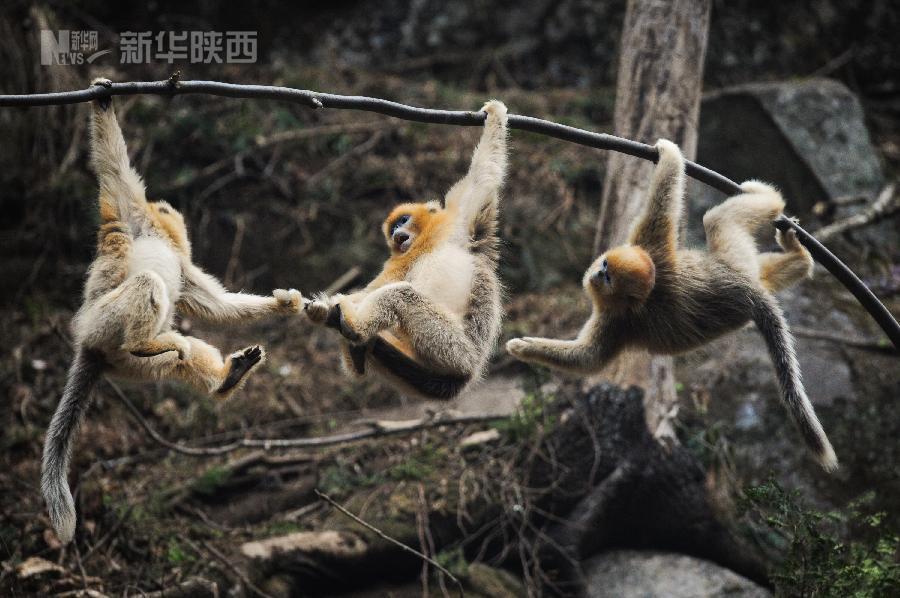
xmin=690 ymin=79 xmax=884 ymax=244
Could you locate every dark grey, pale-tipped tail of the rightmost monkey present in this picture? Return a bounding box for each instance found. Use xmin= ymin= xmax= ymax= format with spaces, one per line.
xmin=753 ymin=292 xmax=838 ymax=471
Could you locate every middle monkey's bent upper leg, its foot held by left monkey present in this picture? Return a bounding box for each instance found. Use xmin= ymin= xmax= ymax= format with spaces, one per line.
xmin=340 ymin=282 xmax=481 ymax=374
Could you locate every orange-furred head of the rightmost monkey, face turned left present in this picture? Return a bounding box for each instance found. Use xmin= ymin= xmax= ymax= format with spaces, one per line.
xmin=583 ymin=245 xmax=656 ymax=308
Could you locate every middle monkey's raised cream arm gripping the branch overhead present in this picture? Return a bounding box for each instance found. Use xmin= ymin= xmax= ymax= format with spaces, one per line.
xmin=445 ymin=100 xmax=507 ymax=235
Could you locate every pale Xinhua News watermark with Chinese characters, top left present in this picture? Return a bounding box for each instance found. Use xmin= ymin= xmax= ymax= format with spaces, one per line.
xmin=41 ymin=29 xmax=257 ymax=66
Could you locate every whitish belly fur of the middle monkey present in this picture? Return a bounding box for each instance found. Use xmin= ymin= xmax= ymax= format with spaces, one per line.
xmin=409 ymin=244 xmax=475 ymax=317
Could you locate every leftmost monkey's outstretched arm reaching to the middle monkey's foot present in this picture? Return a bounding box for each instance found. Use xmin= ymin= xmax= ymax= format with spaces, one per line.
xmin=178 ymin=264 xmax=303 ymax=323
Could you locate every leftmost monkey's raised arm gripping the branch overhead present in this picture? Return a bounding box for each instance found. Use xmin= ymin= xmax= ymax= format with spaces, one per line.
xmin=91 ymin=79 xmax=147 ymax=232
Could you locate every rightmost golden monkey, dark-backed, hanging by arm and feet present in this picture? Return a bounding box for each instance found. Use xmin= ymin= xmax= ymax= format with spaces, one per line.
xmin=506 ymin=140 xmax=837 ymax=471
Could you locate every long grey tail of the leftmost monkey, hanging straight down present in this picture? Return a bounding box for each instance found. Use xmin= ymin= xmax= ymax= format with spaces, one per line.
xmin=41 ymin=350 xmax=103 ymax=544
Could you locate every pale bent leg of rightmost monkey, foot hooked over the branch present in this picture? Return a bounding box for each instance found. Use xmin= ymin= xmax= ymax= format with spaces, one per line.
xmin=703 ymin=181 xmax=784 ymax=280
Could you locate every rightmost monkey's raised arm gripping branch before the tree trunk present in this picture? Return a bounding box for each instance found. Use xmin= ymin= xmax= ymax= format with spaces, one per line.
xmin=628 ymin=139 xmax=684 ymax=261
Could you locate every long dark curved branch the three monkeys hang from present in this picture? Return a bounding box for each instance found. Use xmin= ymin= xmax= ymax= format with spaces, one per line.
xmin=0 ymin=80 xmax=900 ymax=349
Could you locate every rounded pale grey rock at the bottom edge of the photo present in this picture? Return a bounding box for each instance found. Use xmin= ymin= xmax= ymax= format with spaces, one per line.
xmin=584 ymin=550 xmax=771 ymax=598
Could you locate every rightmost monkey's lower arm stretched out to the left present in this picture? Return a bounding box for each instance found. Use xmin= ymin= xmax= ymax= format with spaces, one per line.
xmin=506 ymin=336 xmax=612 ymax=374
